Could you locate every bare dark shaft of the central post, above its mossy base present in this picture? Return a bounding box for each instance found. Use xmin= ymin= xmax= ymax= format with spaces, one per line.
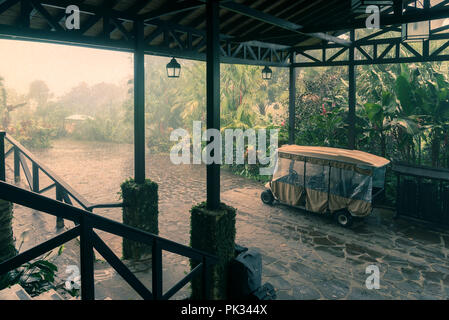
xmin=206 ymin=0 xmax=220 ymax=210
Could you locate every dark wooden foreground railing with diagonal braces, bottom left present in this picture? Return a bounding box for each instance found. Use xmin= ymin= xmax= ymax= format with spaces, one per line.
xmin=0 ymin=180 xmax=217 ymax=300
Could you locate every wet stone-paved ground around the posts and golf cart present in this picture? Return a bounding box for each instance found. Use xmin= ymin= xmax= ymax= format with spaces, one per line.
xmin=7 ymin=141 xmax=449 ymax=299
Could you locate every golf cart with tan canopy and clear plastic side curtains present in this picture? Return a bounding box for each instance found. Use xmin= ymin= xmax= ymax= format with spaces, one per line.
xmin=261 ymin=145 xmax=390 ymax=227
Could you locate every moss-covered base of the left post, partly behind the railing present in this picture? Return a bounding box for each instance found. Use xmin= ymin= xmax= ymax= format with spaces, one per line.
xmin=121 ymin=179 xmax=159 ymax=259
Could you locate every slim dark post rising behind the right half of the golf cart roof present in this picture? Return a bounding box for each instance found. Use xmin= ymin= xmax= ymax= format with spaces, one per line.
xmin=348 ymin=30 xmax=356 ymax=149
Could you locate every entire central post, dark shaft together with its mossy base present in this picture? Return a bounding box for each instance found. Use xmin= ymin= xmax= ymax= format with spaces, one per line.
xmin=190 ymin=0 xmax=236 ymax=300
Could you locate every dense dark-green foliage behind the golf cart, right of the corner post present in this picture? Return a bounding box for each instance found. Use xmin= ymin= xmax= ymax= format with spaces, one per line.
xmin=284 ymin=63 xmax=449 ymax=171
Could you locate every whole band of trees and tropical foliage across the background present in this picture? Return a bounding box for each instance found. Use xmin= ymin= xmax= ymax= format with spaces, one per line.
xmin=0 ymin=51 xmax=449 ymax=176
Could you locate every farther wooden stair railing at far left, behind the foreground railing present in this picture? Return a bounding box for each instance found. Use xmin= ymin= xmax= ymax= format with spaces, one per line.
xmin=0 ymin=132 xmax=123 ymax=228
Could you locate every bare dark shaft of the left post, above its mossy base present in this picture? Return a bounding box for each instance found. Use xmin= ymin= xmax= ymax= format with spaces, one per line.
xmin=134 ymin=20 xmax=145 ymax=183
